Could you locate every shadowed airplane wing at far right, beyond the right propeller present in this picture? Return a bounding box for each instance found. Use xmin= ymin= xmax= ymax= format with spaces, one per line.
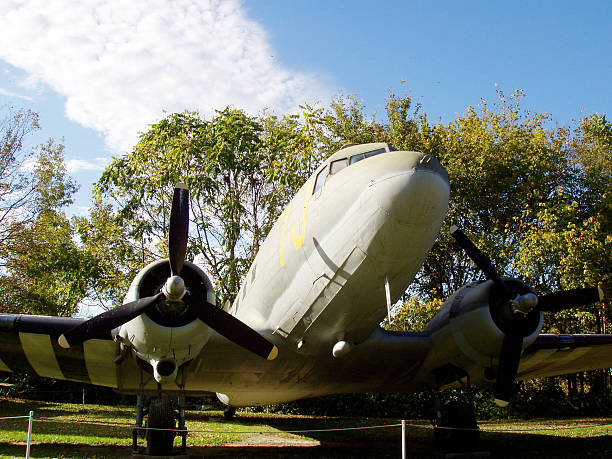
xmin=517 ymin=334 xmax=612 ymax=379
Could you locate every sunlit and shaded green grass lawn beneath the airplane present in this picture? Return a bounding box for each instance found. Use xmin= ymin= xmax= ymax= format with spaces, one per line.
xmin=0 ymin=399 xmax=612 ymax=458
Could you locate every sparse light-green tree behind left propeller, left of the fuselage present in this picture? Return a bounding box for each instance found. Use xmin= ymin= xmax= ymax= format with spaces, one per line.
xmin=91 ymin=97 xmax=388 ymax=304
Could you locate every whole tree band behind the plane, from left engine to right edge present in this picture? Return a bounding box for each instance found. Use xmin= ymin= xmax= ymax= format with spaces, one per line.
xmin=85 ymin=91 xmax=612 ymax=336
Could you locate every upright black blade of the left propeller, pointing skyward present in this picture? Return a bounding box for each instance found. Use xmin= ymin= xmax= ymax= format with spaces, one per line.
xmin=168 ymin=183 xmax=189 ymax=276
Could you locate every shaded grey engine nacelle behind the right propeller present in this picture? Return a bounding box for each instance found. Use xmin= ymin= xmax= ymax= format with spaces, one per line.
xmin=425 ymin=279 xmax=543 ymax=385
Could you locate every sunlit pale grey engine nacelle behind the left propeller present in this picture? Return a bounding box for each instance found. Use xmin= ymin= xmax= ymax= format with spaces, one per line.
xmin=118 ymin=259 xmax=215 ymax=384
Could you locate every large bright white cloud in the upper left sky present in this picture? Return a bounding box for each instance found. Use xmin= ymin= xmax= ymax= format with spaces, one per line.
xmin=0 ymin=0 xmax=329 ymax=152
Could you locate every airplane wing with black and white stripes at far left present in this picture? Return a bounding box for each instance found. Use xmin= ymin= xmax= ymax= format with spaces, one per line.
xmin=0 ymin=314 xmax=118 ymax=387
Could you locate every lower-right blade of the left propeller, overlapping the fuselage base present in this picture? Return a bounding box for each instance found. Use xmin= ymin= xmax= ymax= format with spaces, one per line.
xmin=192 ymin=301 xmax=278 ymax=360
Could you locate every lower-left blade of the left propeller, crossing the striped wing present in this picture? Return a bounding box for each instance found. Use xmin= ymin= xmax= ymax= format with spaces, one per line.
xmin=57 ymin=292 xmax=164 ymax=349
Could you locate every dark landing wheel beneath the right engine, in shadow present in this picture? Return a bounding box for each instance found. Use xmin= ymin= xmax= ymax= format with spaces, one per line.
xmin=434 ymin=402 xmax=480 ymax=453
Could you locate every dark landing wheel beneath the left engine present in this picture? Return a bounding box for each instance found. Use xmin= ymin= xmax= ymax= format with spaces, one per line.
xmin=147 ymin=397 xmax=176 ymax=456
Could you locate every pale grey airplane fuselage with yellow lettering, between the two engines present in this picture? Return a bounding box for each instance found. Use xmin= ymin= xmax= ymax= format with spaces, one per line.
xmin=230 ymin=144 xmax=449 ymax=348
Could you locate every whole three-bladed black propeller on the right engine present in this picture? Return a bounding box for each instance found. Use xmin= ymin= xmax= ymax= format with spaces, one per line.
xmin=450 ymin=225 xmax=603 ymax=407
